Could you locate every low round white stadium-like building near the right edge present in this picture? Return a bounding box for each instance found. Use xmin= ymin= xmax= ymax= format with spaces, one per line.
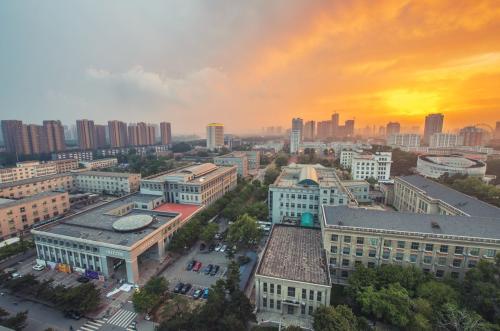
xmin=417 ymin=154 xmax=486 ymax=178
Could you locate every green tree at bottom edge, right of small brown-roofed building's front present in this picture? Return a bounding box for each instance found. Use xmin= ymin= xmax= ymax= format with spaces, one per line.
xmin=313 ymin=305 xmax=357 ymax=331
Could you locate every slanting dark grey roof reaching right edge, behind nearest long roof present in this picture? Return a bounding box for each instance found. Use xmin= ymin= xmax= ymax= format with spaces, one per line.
xmin=398 ymin=175 xmax=500 ymax=218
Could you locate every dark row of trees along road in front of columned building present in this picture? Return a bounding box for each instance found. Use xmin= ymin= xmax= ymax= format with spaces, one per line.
xmin=2 ymin=274 xmax=101 ymax=314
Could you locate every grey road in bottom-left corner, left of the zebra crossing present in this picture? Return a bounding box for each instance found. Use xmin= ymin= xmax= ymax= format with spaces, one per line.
xmin=0 ymin=293 xmax=87 ymax=331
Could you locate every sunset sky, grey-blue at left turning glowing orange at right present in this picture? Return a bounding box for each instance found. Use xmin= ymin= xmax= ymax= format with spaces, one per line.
xmin=0 ymin=0 xmax=500 ymax=134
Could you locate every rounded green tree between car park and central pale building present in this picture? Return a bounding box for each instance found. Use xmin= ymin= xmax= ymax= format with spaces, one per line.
xmin=227 ymin=214 xmax=262 ymax=250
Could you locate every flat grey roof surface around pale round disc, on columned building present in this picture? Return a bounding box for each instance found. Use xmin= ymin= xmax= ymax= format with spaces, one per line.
xmin=35 ymin=193 xmax=178 ymax=247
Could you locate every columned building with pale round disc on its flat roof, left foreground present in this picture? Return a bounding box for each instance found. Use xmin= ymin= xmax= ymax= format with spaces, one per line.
xmin=31 ymin=194 xmax=201 ymax=283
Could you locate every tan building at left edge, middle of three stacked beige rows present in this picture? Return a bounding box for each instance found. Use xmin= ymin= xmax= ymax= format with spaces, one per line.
xmin=0 ymin=173 xmax=74 ymax=199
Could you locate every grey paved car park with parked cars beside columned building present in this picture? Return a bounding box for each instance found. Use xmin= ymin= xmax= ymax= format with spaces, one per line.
xmin=163 ymin=243 xmax=228 ymax=295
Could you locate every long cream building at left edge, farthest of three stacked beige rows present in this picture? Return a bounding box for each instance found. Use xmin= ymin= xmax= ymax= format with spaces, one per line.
xmin=0 ymin=159 xmax=78 ymax=183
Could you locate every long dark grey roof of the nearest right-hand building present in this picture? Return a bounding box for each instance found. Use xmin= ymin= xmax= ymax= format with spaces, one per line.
xmin=324 ymin=206 xmax=500 ymax=240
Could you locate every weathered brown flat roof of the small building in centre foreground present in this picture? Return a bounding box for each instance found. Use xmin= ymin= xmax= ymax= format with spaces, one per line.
xmin=256 ymin=224 xmax=330 ymax=285
